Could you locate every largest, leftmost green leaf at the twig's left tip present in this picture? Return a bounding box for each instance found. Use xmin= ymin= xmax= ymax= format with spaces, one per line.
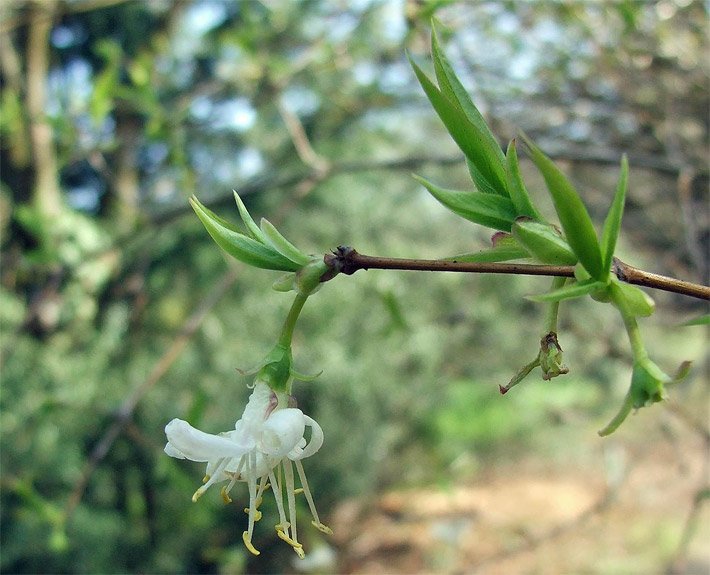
xmin=190 ymin=196 xmax=300 ymax=271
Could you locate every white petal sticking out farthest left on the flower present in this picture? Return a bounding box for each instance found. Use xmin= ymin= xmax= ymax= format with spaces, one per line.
xmin=165 ymin=419 xmax=250 ymax=461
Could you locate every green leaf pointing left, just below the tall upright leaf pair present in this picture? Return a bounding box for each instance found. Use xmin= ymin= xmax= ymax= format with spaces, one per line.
xmin=414 ymin=175 xmax=515 ymax=232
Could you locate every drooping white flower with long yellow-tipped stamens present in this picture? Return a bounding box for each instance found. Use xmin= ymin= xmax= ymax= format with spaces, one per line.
xmin=165 ymin=380 xmax=332 ymax=558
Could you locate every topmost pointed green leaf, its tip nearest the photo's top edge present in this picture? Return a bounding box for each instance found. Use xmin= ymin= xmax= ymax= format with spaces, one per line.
xmin=431 ymin=26 xmax=505 ymax=169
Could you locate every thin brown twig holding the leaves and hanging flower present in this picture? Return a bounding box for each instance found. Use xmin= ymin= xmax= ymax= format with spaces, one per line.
xmin=323 ymin=246 xmax=710 ymax=300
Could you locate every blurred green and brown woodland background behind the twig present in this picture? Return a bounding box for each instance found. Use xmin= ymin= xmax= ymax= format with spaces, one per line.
xmin=0 ymin=0 xmax=710 ymax=574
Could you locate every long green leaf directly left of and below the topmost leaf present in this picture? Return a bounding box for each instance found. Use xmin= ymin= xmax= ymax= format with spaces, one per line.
xmin=409 ymin=58 xmax=508 ymax=197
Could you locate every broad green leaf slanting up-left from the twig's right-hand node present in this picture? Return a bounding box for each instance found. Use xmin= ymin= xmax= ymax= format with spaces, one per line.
xmin=523 ymin=135 xmax=609 ymax=282
